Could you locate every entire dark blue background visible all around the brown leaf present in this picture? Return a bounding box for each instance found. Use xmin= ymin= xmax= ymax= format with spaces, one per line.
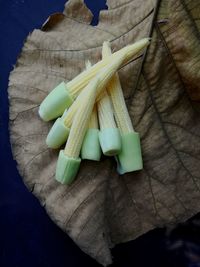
xmin=0 ymin=0 xmax=199 ymax=267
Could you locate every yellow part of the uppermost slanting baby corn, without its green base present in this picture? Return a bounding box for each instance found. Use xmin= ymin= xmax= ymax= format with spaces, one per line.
xmin=67 ymin=38 xmax=150 ymax=98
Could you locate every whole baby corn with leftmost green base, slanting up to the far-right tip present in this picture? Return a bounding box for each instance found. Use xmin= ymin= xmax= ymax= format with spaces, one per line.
xmin=39 ymin=38 xmax=150 ymax=121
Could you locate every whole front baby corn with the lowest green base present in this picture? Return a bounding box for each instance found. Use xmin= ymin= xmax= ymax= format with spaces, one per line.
xmin=56 ymin=78 xmax=98 ymax=184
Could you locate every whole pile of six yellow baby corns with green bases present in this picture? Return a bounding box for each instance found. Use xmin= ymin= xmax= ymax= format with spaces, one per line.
xmin=39 ymin=38 xmax=150 ymax=184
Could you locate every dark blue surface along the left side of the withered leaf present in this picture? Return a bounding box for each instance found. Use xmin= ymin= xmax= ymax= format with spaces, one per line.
xmin=0 ymin=0 xmax=103 ymax=267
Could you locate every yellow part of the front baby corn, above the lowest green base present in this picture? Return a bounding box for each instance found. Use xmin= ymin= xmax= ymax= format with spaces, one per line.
xmin=64 ymin=78 xmax=98 ymax=158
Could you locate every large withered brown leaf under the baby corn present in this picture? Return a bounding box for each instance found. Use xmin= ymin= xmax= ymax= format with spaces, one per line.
xmin=9 ymin=0 xmax=200 ymax=265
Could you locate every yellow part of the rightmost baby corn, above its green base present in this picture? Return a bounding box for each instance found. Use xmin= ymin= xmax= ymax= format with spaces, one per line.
xmin=103 ymin=42 xmax=134 ymax=133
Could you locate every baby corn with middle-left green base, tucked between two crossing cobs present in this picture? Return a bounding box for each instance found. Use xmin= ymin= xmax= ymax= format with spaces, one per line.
xmin=48 ymin=52 xmax=124 ymax=148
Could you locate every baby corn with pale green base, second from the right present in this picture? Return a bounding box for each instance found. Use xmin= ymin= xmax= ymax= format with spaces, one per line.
xmin=98 ymin=45 xmax=121 ymax=156
